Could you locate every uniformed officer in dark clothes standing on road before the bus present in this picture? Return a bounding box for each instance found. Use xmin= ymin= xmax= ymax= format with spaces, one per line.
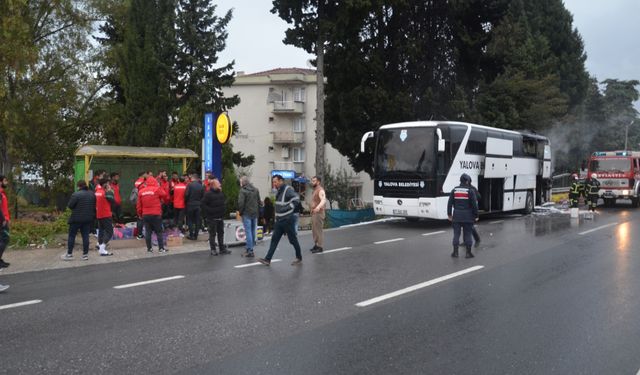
xmin=447 ymin=173 xmax=478 ymax=258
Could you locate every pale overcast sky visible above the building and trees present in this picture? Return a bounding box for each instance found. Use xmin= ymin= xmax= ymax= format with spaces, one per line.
xmin=214 ymin=0 xmax=640 ymax=92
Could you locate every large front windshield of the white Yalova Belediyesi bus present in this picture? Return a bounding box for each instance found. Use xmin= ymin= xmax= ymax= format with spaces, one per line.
xmin=375 ymin=127 xmax=436 ymax=176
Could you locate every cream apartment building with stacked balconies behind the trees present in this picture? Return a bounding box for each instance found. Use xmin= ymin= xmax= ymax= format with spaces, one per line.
xmin=224 ymin=68 xmax=373 ymax=208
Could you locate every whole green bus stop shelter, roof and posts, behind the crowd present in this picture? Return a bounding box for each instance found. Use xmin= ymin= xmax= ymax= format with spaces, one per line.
xmin=74 ymin=145 xmax=199 ymax=213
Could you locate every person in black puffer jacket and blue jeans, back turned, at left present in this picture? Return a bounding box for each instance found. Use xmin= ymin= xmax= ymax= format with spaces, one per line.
xmin=62 ymin=180 xmax=96 ymax=260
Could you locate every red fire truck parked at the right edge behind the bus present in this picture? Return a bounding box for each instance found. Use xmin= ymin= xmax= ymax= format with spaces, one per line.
xmin=588 ymin=151 xmax=640 ymax=207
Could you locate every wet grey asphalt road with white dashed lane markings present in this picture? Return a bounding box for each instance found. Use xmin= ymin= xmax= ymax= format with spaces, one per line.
xmin=0 ymin=206 xmax=640 ymax=374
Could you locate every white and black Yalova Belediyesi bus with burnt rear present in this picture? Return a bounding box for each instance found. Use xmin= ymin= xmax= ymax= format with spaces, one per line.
xmin=360 ymin=121 xmax=551 ymax=221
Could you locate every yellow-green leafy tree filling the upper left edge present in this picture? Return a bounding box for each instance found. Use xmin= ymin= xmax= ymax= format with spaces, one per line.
xmin=0 ymin=0 xmax=97 ymax=187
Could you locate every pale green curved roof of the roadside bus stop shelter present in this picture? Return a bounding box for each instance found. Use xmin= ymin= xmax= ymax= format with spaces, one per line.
xmin=75 ymin=145 xmax=199 ymax=159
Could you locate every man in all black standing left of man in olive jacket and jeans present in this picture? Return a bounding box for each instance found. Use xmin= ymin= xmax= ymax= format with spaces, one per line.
xmin=202 ymin=175 xmax=231 ymax=255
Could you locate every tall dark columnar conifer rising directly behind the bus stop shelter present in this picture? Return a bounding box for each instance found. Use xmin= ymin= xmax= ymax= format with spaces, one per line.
xmin=117 ymin=0 xmax=176 ymax=146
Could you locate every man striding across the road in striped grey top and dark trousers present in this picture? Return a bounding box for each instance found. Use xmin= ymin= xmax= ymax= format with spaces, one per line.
xmin=258 ymin=174 xmax=302 ymax=266
